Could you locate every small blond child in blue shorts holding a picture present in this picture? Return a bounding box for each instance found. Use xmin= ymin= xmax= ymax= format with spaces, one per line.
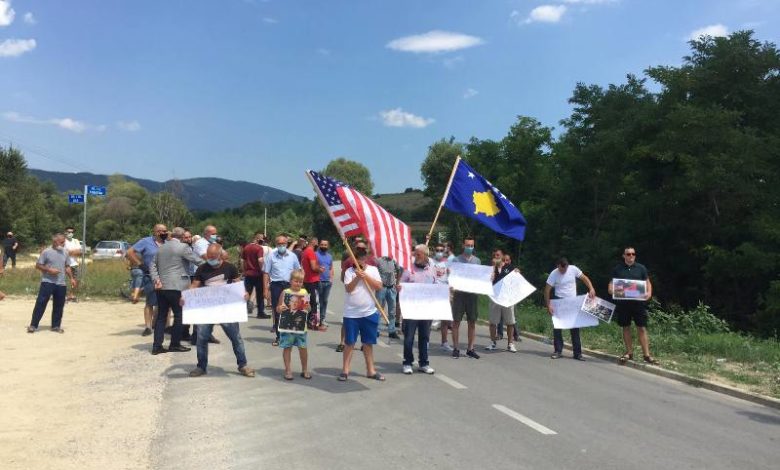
xmin=276 ymin=269 xmax=311 ymax=380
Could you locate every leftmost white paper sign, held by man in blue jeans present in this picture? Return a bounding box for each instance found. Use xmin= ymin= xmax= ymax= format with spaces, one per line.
xmin=181 ymin=282 xmax=247 ymax=325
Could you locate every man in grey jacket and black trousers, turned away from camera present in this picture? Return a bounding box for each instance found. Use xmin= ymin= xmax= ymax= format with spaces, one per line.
xmin=149 ymin=227 xmax=203 ymax=355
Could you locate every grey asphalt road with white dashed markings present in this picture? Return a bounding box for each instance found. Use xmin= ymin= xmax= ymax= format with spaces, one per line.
xmin=150 ymin=278 xmax=780 ymax=470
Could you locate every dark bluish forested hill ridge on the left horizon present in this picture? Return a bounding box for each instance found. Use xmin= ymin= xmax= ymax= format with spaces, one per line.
xmin=28 ymin=169 xmax=306 ymax=212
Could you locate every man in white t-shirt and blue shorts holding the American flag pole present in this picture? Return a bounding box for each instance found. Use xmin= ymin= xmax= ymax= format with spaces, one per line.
xmin=339 ymin=251 xmax=385 ymax=382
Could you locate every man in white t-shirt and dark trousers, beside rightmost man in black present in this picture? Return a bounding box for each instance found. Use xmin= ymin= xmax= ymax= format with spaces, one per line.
xmin=544 ymin=258 xmax=596 ymax=361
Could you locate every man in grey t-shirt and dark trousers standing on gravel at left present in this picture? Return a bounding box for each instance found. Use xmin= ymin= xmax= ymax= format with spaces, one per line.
xmin=27 ymin=233 xmax=77 ymax=333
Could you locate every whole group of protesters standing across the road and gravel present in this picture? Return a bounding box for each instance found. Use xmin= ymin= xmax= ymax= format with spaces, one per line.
xmin=16 ymin=224 xmax=658 ymax=381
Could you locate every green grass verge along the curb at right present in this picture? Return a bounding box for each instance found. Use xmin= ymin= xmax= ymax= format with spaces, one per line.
xmin=479 ymin=296 xmax=780 ymax=398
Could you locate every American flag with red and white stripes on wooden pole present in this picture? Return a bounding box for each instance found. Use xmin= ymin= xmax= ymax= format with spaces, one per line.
xmin=307 ymin=170 xmax=412 ymax=269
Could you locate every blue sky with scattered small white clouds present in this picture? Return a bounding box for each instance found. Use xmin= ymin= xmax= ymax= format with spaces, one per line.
xmin=0 ymin=0 xmax=780 ymax=196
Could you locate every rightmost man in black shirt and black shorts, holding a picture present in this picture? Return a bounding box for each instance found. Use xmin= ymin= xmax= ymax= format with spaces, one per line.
xmin=608 ymin=246 xmax=658 ymax=365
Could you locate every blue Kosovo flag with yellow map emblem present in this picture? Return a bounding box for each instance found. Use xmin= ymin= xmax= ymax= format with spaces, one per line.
xmin=444 ymin=159 xmax=526 ymax=241
